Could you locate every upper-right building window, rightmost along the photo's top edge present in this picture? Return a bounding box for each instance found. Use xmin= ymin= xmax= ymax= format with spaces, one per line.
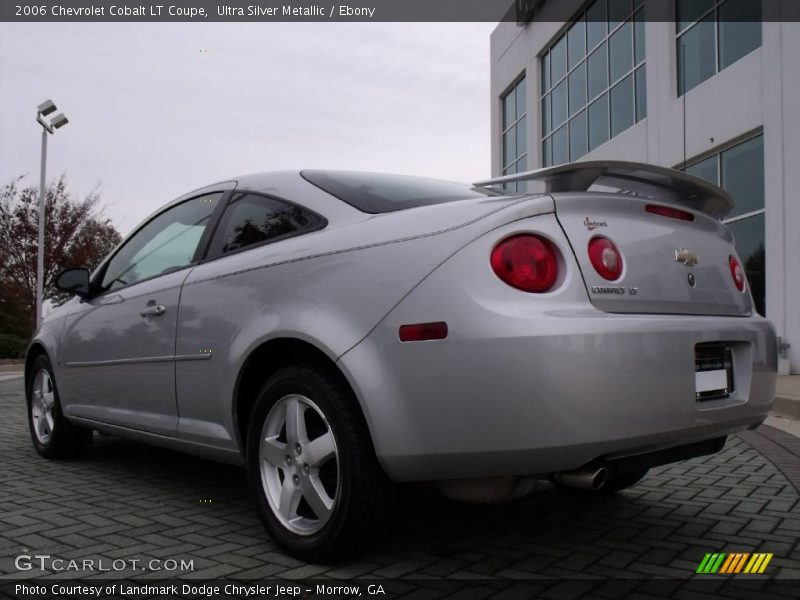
xmin=675 ymin=0 xmax=761 ymax=96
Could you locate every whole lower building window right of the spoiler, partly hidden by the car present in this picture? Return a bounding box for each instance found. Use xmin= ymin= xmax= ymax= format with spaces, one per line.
xmin=685 ymin=135 xmax=766 ymax=315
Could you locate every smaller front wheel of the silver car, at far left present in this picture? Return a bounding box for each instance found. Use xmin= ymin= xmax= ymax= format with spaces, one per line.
xmin=25 ymin=355 xmax=92 ymax=459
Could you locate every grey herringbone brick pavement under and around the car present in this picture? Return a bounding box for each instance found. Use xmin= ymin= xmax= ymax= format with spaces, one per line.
xmin=0 ymin=380 xmax=800 ymax=579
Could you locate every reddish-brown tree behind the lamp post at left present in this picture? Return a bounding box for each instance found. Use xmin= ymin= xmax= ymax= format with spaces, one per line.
xmin=0 ymin=175 xmax=121 ymax=338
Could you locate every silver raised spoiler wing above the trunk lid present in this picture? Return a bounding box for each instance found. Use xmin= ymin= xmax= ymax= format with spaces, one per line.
xmin=474 ymin=160 xmax=733 ymax=219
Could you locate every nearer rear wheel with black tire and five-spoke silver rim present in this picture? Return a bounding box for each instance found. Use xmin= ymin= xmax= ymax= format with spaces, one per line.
xmin=247 ymin=365 xmax=388 ymax=561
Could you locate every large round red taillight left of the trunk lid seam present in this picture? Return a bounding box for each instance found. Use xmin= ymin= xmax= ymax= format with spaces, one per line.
xmin=491 ymin=234 xmax=558 ymax=293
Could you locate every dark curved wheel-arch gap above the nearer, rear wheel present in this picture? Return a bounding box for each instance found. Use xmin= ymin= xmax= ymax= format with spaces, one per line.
xmin=233 ymin=337 xmax=374 ymax=456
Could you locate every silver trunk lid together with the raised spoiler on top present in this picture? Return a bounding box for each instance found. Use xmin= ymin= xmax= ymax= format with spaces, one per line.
xmin=476 ymin=160 xmax=752 ymax=316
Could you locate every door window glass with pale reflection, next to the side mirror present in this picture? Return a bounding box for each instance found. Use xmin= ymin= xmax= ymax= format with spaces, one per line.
xmin=101 ymin=192 xmax=222 ymax=291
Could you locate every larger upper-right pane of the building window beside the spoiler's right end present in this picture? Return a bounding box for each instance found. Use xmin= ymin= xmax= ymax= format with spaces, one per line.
xmin=720 ymin=136 xmax=764 ymax=218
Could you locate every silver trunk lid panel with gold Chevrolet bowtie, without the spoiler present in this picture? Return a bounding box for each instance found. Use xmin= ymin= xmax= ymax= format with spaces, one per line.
xmin=553 ymin=192 xmax=752 ymax=316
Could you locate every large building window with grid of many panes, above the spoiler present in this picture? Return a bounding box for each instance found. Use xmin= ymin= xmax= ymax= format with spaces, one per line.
xmin=540 ymin=0 xmax=648 ymax=167
